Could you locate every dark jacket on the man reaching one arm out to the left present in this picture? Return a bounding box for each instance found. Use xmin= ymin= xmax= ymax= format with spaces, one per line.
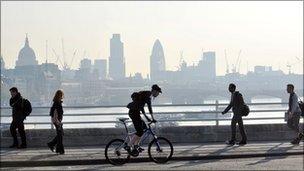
xmin=223 ymin=91 xmax=244 ymax=115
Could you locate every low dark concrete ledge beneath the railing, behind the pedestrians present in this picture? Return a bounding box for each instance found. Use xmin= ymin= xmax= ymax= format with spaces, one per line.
xmin=1 ymin=124 xmax=295 ymax=148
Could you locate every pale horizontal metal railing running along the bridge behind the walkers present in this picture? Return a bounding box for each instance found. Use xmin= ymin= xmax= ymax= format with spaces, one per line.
xmin=0 ymin=101 xmax=294 ymax=128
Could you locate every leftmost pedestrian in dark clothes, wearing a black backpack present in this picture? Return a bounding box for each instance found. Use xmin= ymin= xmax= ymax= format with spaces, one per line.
xmin=10 ymin=87 xmax=26 ymax=148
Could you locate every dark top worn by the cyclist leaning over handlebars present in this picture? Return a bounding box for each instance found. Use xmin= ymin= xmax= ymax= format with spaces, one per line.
xmin=127 ymin=91 xmax=153 ymax=113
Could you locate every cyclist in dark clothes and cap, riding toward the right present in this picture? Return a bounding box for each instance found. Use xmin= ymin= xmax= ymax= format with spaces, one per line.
xmin=126 ymin=84 xmax=162 ymax=155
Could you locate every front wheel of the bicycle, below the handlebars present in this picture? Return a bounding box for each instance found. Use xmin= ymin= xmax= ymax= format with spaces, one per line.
xmin=148 ymin=137 xmax=173 ymax=163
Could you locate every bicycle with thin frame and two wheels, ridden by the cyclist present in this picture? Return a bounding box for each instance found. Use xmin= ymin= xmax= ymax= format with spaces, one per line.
xmin=105 ymin=118 xmax=173 ymax=165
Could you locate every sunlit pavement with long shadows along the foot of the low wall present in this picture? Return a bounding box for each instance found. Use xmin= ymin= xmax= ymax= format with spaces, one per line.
xmin=0 ymin=141 xmax=304 ymax=167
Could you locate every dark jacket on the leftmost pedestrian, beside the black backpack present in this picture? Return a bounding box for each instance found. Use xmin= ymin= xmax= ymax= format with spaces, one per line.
xmin=10 ymin=93 xmax=25 ymax=120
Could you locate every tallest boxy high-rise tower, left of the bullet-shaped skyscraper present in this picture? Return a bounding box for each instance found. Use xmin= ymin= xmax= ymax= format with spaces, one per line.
xmin=109 ymin=34 xmax=126 ymax=80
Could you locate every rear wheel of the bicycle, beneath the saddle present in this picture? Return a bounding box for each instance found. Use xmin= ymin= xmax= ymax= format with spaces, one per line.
xmin=105 ymin=139 xmax=130 ymax=165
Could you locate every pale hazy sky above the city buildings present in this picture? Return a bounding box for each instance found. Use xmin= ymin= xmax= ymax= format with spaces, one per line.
xmin=1 ymin=1 xmax=303 ymax=76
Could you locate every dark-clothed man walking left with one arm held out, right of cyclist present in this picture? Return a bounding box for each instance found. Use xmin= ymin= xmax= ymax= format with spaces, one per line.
xmin=222 ymin=84 xmax=247 ymax=145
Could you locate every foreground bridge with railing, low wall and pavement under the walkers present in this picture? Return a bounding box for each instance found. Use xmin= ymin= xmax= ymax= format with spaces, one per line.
xmin=1 ymin=103 xmax=303 ymax=170
